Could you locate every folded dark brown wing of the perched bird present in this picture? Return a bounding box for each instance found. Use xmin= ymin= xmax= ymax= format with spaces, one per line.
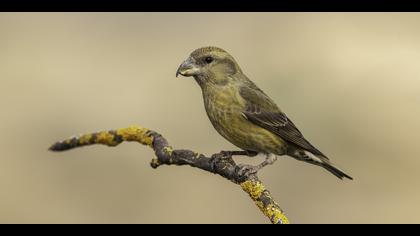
xmin=240 ymin=84 xmax=326 ymax=157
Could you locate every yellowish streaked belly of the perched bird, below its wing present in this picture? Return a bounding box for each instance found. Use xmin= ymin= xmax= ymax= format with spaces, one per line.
xmin=207 ymin=104 xmax=286 ymax=155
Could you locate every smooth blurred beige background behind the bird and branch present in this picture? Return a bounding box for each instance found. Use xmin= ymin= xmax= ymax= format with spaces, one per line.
xmin=0 ymin=13 xmax=420 ymax=223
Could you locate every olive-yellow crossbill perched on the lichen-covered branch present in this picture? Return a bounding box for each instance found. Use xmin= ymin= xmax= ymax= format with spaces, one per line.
xmin=176 ymin=46 xmax=353 ymax=180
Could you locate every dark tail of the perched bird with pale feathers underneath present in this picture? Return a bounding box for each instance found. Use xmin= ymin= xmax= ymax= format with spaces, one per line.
xmin=288 ymin=150 xmax=353 ymax=180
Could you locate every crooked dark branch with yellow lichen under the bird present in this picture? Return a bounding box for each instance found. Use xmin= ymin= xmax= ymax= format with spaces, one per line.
xmin=50 ymin=126 xmax=289 ymax=224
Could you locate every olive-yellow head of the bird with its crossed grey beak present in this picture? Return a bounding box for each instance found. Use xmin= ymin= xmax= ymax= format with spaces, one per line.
xmin=176 ymin=47 xmax=242 ymax=84
